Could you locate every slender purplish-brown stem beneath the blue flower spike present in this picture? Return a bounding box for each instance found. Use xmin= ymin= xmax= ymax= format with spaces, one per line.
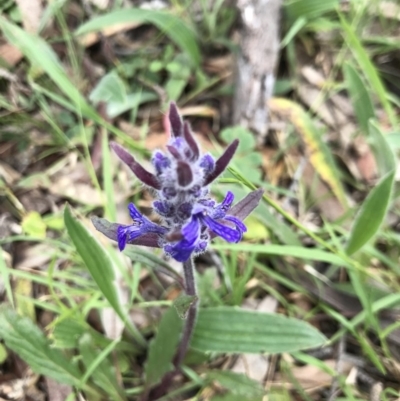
xmin=174 ymin=258 xmax=198 ymax=368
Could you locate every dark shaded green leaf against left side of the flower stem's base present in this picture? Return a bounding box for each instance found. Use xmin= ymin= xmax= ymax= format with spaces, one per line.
xmin=145 ymin=307 xmax=183 ymax=386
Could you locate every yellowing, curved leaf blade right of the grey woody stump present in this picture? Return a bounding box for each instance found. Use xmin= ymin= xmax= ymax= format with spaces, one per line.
xmin=269 ymin=98 xmax=347 ymax=207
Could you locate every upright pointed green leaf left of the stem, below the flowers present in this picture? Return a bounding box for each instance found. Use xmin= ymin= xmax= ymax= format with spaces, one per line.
xmin=64 ymin=206 xmax=146 ymax=346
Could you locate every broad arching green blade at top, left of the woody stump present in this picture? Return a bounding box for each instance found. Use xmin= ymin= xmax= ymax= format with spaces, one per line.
xmin=75 ymin=8 xmax=200 ymax=65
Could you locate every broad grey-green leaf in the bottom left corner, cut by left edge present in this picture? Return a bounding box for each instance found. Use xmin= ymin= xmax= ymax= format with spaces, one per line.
xmin=0 ymin=306 xmax=81 ymax=386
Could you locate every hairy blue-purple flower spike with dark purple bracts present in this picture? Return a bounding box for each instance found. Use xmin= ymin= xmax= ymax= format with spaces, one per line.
xmin=93 ymin=103 xmax=263 ymax=262
